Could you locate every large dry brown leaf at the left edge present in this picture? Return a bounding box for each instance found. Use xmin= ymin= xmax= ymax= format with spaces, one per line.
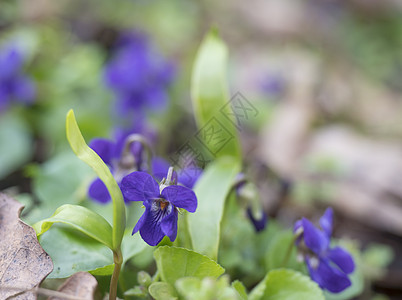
xmin=0 ymin=193 xmax=53 ymax=300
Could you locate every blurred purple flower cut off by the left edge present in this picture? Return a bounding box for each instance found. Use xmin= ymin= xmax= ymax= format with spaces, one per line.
xmin=0 ymin=48 xmax=35 ymax=111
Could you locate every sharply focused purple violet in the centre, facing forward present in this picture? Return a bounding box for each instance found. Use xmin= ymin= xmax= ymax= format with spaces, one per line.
xmin=121 ymin=172 xmax=197 ymax=246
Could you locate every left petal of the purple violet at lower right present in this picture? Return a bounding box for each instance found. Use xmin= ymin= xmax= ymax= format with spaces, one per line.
xmin=302 ymin=218 xmax=329 ymax=255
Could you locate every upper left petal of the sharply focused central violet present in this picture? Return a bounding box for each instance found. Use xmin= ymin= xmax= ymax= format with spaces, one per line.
xmin=120 ymin=172 xmax=159 ymax=201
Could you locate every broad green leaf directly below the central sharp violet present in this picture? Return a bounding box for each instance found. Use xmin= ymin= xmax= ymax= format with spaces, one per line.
xmin=154 ymin=246 xmax=225 ymax=285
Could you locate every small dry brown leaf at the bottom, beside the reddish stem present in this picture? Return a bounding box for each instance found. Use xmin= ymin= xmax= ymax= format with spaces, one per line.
xmin=48 ymin=272 xmax=98 ymax=300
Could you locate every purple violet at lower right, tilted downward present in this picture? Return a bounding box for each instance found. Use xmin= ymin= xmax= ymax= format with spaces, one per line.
xmin=294 ymin=208 xmax=355 ymax=293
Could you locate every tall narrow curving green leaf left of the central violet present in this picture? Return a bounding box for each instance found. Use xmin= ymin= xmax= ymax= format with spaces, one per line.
xmin=66 ymin=110 xmax=126 ymax=250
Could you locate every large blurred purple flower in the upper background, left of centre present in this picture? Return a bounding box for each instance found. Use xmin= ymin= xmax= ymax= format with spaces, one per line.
xmin=105 ymin=34 xmax=175 ymax=115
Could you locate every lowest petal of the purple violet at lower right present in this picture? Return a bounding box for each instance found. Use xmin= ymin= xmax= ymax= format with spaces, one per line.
xmin=307 ymin=259 xmax=352 ymax=293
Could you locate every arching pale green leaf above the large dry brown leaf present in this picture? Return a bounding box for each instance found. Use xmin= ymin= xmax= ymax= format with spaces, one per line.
xmin=32 ymin=204 xmax=113 ymax=250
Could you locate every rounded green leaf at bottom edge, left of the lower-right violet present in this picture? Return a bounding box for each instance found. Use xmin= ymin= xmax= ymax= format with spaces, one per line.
xmin=249 ymin=269 xmax=325 ymax=300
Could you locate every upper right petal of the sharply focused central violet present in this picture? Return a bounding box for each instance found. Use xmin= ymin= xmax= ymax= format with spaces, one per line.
xmin=162 ymin=185 xmax=197 ymax=212
